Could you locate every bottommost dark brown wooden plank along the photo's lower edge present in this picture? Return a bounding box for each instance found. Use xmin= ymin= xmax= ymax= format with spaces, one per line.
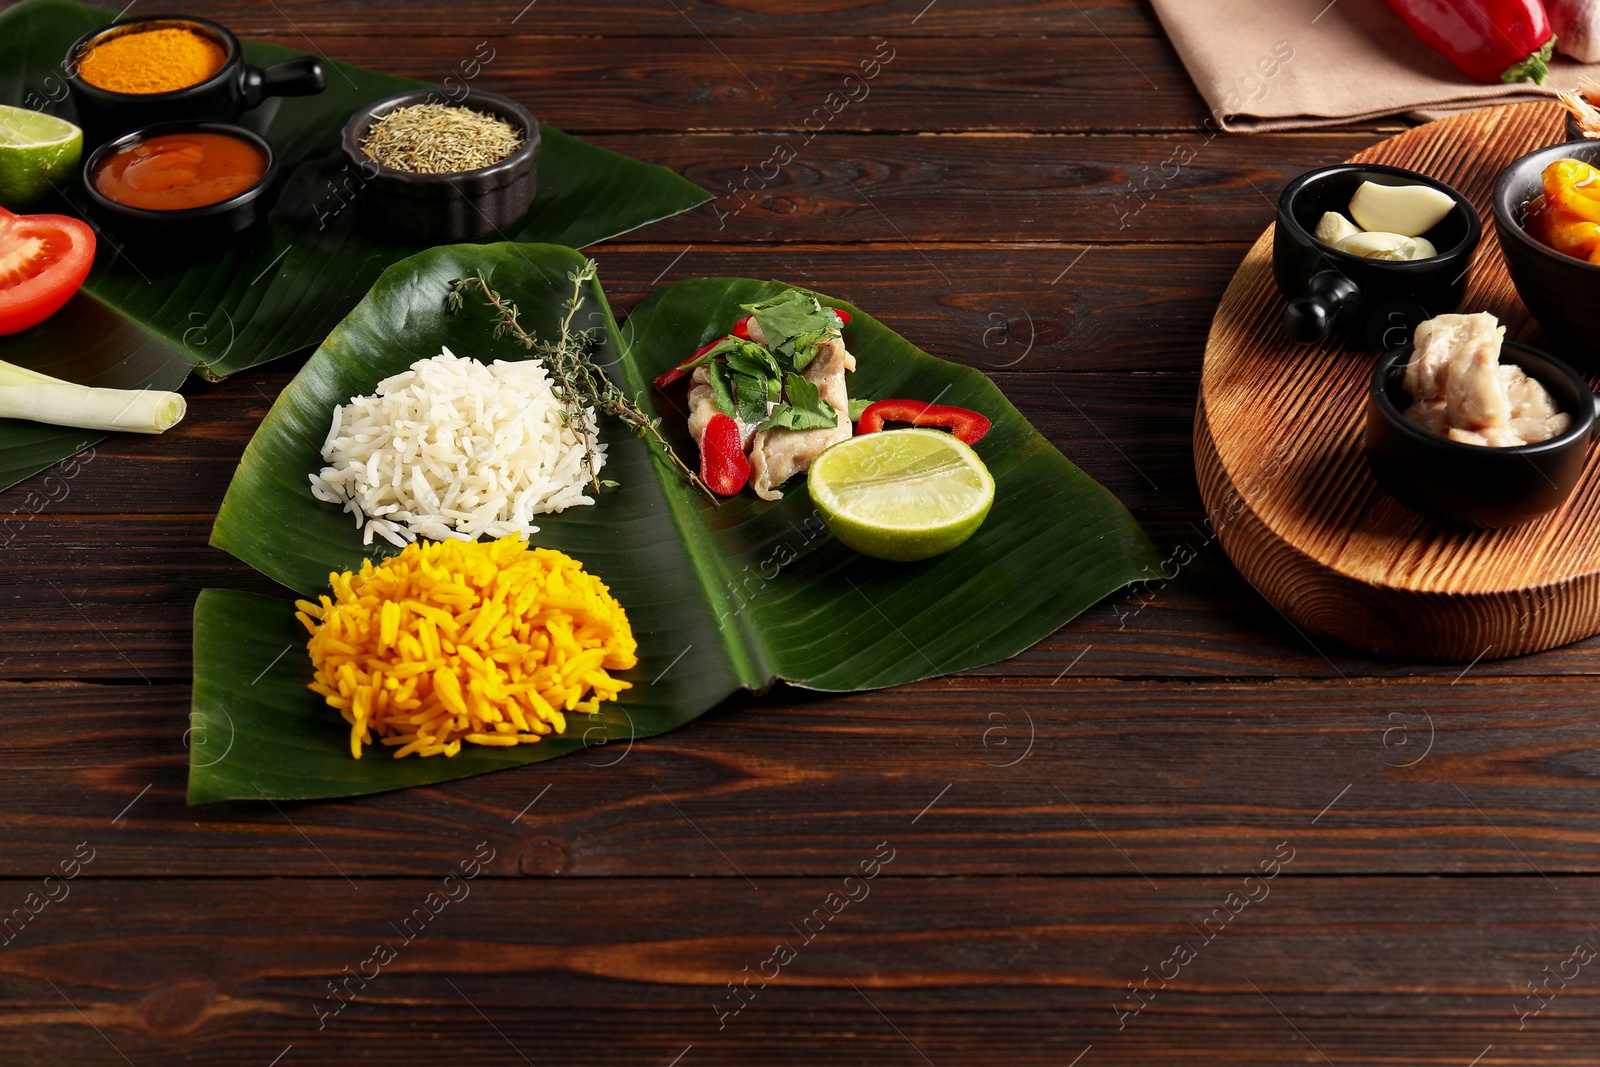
xmin=0 ymin=883 xmax=1600 ymax=1067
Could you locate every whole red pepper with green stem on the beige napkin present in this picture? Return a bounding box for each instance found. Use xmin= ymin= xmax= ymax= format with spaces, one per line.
xmin=1384 ymin=0 xmax=1555 ymax=85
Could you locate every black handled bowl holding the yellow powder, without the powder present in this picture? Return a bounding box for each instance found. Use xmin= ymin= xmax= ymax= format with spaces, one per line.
xmin=64 ymin=14 xmax=328 ymax=146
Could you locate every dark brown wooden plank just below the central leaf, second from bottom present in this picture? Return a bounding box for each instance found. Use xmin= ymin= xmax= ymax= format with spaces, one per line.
xmin=9 ymin=667 xmax=1600 ymax=885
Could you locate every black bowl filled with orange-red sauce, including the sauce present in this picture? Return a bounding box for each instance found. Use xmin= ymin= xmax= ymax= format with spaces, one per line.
xmin=83 ymin=122 xmax=278 ymax=246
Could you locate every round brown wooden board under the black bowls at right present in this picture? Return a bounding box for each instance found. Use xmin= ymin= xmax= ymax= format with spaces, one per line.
xmin=1195 ymin=102 xmax=1600 ymax=661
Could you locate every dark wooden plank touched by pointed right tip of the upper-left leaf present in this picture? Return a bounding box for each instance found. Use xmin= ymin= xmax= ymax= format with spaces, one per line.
xmin=592 ymin=131 xmax=1384 ymax=244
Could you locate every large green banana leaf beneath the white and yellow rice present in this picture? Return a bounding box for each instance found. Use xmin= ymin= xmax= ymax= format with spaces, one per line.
xmin=189 ymin=245 xmax=1160 ymax=803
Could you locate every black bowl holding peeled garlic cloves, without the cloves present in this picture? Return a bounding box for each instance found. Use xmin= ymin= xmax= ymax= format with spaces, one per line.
xmin=1272 ymin=163 xmax=1483 ymax=352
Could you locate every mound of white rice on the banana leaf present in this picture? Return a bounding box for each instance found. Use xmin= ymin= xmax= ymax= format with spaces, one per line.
xmin=310 ymin=349 xmax=605 ymax=545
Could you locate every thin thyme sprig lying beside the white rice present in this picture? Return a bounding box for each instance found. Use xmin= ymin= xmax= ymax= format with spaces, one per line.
xmin=446 ymin=259 xmax=718 ymax=504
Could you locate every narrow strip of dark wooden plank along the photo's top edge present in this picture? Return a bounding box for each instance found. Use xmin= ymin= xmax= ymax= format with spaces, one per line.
xmin=159 ymin=0 xmax=1162 ymax=40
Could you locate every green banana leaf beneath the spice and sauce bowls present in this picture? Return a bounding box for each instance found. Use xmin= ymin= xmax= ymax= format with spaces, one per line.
xmin=0 ymin=0 xmax=710 ymax=490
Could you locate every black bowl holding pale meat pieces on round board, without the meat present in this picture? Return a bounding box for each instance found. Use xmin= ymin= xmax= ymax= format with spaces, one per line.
xmin=1366 ymin=341 xmax=1600 ymax=530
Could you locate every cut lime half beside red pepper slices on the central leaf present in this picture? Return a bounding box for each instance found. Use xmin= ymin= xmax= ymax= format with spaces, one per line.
xmin=806 ymin=429 xmax=995 ymax=560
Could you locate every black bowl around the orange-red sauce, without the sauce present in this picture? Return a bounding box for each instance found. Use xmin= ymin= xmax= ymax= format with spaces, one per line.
xmin=83 ymin=122 xmax=278 ymax=247
